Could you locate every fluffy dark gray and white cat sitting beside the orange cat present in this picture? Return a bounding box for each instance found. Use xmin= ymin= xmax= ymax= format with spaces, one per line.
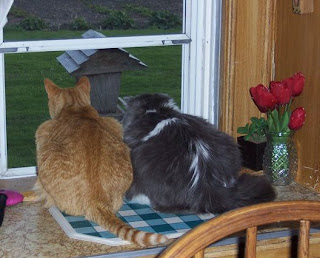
xmin=122 ymin=94 xmax=275 ymax=213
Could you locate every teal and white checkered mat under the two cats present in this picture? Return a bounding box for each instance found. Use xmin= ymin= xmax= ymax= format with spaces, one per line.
xmin=49 ymin=202 xmax=214 ymax=246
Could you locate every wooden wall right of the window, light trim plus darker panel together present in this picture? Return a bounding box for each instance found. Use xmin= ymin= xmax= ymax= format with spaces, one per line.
xmin=220 ymin=0 xmax=320 ymax=192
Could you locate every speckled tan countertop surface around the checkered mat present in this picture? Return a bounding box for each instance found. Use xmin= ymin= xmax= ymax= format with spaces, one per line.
xmin=0 ymin=177 xmax=320 ymax=258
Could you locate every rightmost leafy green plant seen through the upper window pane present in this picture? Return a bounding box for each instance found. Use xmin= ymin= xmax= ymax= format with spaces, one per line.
xmin=150 ymin=10 xmax=181 ymax=29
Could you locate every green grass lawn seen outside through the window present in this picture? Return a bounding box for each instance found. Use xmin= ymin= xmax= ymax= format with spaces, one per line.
xmin=4 ymin=30 xmax=181 ymax=167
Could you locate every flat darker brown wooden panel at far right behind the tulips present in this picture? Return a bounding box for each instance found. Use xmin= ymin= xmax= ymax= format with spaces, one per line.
xmin=275 ymin=0 xmax=320 ymax=192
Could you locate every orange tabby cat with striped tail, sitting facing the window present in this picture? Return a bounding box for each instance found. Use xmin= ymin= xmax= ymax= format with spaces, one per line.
xmin=35 ymin=77 xmax=168 ymax=246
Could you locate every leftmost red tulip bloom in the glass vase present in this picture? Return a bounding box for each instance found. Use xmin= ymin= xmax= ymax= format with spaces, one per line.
xmin=250 ymin=84 xmax=277 ymax=113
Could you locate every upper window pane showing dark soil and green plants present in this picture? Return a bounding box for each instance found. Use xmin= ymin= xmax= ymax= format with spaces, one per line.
xmin=4 ymin=0 xmax=183 ymax=41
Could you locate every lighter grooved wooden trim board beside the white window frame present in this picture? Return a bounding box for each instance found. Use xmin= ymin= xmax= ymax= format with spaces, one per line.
xmin=219 ymin=0 xmax=275 ymax=137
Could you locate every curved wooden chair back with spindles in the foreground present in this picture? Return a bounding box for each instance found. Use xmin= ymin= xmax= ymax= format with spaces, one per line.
xmin=158 ymin=201 xmax=320 ymax=258
